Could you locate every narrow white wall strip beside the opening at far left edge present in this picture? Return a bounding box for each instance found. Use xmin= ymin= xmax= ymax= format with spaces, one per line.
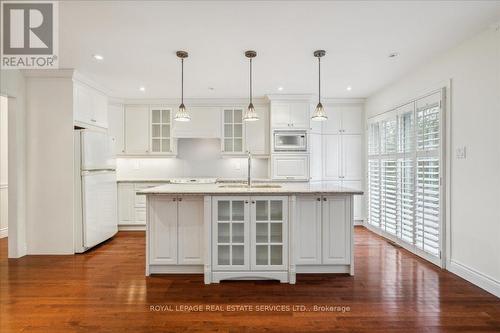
xmin=0 ymin=70 xmax=26 ymax=258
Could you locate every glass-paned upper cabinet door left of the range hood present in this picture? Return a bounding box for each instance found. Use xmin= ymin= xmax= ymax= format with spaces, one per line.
xmin=151 ymin=107 xmax=172 ymax=153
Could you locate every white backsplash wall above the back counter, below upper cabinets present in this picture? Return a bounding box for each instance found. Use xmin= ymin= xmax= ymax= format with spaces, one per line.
xmin=117 ymin=139 xmax=268 ymax=180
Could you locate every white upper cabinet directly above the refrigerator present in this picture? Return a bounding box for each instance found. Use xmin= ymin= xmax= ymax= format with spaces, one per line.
xmin=73 ymin=82 xmax=108 ymax=128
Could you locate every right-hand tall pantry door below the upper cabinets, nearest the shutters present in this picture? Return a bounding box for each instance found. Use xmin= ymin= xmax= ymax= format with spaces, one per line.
xmin=342 ymin=135 xmax=364 ymax=180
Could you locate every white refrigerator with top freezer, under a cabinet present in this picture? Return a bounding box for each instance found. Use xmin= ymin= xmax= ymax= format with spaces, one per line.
xmin=74 ymin=130 xmax=118 ymax=253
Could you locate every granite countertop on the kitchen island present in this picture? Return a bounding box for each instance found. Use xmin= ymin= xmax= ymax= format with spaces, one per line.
xmin=137 ymin=182 xmax=363 ymax=195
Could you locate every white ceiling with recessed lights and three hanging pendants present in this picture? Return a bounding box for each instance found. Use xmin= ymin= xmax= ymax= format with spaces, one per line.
xmin=59 ymin=1 xmax=500 ymax=98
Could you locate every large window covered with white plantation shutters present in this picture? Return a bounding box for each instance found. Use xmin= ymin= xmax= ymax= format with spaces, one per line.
xmin=368 ymin=93 xmax=443 ymax=263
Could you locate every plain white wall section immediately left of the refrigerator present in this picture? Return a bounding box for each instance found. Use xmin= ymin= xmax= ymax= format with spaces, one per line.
xmin=26 ymin=76 xmax=74 ymax=254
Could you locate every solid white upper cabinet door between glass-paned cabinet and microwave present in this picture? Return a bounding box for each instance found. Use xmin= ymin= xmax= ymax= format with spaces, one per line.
xmin=244 ymin=107 xmax=270 ymax=155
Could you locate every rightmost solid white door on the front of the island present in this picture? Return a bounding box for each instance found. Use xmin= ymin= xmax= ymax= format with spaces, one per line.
xmin=322 ymin=196 xmax=352 ymax=265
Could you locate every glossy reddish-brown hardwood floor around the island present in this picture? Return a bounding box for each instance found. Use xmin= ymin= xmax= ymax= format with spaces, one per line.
xmin=0 ymin=227 xmax=500 ymax=333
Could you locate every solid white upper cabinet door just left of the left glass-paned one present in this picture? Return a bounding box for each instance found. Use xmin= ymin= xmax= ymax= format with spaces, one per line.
xmin=125 ymin=105 xmax=150 ymax=155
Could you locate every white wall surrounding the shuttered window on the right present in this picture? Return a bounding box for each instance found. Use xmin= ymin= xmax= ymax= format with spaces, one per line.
xmin=366 ymin=26 xmax=500 ymax=296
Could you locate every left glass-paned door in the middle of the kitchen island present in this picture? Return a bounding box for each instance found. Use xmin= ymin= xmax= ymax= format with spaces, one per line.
xmin=212 ymin=197 xmax=250 ymax=271
